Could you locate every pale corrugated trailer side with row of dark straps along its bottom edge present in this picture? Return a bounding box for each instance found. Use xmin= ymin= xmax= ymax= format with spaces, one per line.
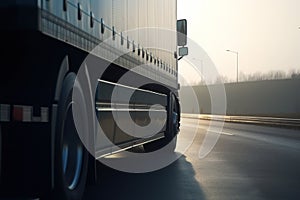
xmin=41 ymin=0 xmax=177 ymax=87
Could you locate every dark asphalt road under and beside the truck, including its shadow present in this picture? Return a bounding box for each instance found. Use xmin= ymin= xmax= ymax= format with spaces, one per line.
xmin=84 ymin=119 xmax=300 ymax=200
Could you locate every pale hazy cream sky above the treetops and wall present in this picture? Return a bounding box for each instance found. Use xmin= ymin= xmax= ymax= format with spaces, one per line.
xmin=178 ymin=0 xmax=300 ymax=79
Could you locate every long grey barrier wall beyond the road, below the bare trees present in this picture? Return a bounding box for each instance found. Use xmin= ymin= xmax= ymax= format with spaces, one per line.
xmin=180 ymin=79 xmax=300 ymax=118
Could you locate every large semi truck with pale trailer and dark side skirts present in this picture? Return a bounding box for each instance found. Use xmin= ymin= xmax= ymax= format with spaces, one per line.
xmin=0 ymin=0 xmax=187 ymax=199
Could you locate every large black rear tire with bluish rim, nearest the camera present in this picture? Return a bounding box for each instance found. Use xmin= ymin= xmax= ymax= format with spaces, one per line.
xmin=51 ymin=73 xmax=89 ymax=200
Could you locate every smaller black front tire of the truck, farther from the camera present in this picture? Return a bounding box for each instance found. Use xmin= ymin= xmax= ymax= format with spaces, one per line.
xmin=143 ymin=93 xmax=180 ymax=153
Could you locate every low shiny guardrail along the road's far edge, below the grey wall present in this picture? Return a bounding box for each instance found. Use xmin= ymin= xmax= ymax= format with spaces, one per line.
xmin=182 ymin=113 xmax=300 ymax=128
